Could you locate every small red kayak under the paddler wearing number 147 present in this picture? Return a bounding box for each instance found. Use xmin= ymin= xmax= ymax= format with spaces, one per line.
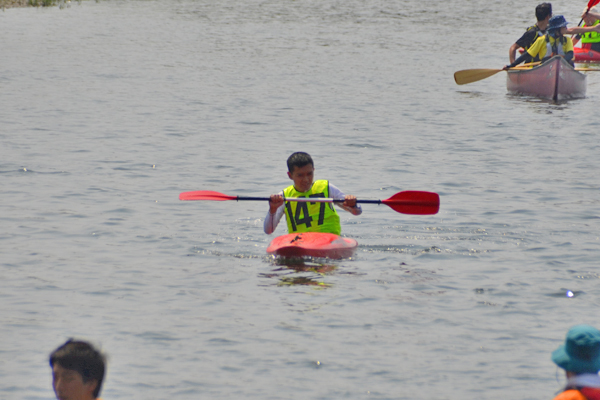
xmin=267 ymin=232 xmax=358 ymax=259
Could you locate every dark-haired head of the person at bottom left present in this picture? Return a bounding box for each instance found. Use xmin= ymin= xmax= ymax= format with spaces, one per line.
xmin=50 ymin=339 xmax=106 ymax=400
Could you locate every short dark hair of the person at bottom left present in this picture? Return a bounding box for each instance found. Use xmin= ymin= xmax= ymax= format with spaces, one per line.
xmin=50 ymin=339 xmax=106 ymax=397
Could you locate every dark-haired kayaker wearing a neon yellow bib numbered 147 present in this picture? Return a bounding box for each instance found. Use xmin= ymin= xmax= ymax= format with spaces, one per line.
xmin=264 ymin=152 xmax=362 ymax=235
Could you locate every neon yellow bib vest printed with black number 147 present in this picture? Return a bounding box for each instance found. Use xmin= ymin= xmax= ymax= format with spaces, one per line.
xmin=283 ymin=180 xmax=342 ymax=235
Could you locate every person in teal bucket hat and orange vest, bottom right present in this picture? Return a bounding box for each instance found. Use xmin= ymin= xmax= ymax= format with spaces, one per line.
xmin=552 ymin=325 xmax=600 ymax=400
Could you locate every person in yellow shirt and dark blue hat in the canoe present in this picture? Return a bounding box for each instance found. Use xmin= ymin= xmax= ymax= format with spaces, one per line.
xmin=503 ymin=15 xmax=573 ymax=69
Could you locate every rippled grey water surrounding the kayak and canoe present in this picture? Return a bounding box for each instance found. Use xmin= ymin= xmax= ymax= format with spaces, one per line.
xmin=0 ymin=0 xmax=600 ymax=400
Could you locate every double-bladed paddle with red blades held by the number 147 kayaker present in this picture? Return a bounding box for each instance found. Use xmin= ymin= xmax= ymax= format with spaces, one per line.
xmin=179 ymin=190 xmax=440 ymax=215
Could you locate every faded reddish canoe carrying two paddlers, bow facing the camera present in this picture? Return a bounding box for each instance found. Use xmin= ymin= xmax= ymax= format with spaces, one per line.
xmin=506 ymin=56 xmax=586 ymax=101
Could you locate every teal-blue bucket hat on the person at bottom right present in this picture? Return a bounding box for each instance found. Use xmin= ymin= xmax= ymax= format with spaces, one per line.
xmin=552 ymin=325 xmax=600 ymax=374
